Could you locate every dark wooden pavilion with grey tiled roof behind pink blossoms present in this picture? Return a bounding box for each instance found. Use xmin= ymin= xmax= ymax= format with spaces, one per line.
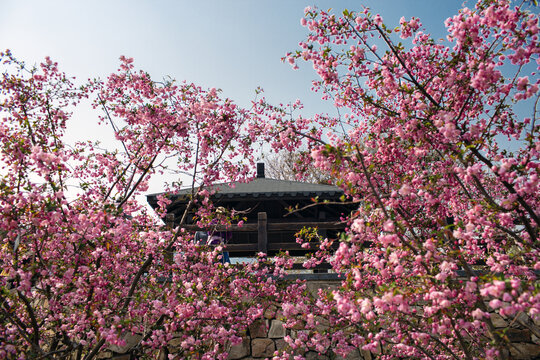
xmin=147 ymin=163 xmax=354 ymax=257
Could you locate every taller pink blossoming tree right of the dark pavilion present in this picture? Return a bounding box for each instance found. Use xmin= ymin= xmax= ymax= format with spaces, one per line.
xmin=259 ymin=0 xmax=540 ymax=359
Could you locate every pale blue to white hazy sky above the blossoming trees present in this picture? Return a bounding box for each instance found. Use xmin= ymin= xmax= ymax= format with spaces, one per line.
xmin=0 ymin=0 xmax=474 ymax=191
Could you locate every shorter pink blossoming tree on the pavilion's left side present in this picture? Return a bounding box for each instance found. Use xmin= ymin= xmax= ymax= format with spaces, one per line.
xmin=0 ymin=52 xmax=304 ymax=359
